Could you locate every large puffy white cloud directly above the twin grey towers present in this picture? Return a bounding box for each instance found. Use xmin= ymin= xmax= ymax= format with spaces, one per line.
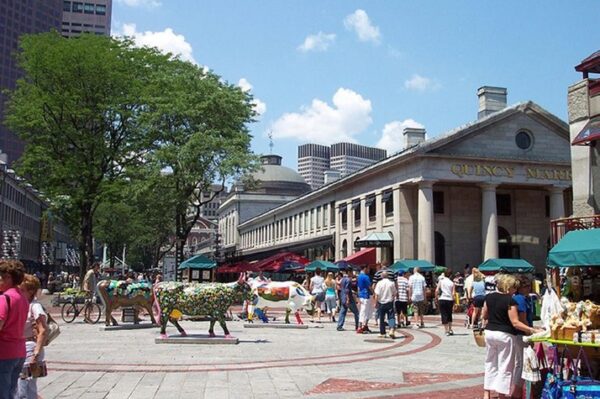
xmin=270 ymin=88 xmax=372 ymax=144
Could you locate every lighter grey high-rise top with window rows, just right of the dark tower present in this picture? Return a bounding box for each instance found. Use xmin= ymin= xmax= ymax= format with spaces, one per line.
xmin=62 ymin=0 xmax=112 ymax=37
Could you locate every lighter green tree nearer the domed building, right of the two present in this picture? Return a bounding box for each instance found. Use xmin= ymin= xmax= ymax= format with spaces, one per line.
xmin=144 ymin=60 xmax=257 ymax=272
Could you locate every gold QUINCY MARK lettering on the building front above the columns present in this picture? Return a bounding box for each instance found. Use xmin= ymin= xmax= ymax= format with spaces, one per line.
xmin=450 ymin=163 xmax=571 ymax=180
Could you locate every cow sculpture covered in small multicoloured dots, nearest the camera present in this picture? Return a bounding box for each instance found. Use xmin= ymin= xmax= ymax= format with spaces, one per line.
xmin=155 ymin=273 xmax=250 ymax=338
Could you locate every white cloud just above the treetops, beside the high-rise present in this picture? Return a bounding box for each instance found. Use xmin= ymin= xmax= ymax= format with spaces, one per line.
xmin=121 ymin=24 xmax=196 ymax=63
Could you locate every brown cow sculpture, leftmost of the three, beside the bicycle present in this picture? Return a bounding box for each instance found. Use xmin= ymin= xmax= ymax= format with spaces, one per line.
xmin=96 ymin=280 xmax=157 ymax=326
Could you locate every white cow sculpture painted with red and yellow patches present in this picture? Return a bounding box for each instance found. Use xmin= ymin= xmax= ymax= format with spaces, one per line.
xmin=248 ymin=281 xmax=315 ymax=324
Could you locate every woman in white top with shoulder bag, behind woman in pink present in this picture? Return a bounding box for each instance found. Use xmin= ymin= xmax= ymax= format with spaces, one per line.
xmin=17 ymin=274 xmax=48 ymax=399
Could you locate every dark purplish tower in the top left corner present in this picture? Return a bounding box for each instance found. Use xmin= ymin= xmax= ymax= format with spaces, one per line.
xmin=0 ymin=0 xmax=63 ymax=165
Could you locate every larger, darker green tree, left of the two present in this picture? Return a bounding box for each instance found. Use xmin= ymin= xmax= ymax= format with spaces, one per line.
xmin=6 ymin=32 xmax=169 ymax=280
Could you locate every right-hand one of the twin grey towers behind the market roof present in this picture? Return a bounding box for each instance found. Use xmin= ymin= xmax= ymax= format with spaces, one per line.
xmin=330 ymin=143 xmax=387 ymax=177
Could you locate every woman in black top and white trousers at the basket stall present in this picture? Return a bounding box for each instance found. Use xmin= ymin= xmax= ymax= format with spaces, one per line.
xmin=482 ymin=274 xmax=537 ymax=399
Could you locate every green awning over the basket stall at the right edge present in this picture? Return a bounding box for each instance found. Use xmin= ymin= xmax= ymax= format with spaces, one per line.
xmin=547 ymin=229 xmax=600 ymax=267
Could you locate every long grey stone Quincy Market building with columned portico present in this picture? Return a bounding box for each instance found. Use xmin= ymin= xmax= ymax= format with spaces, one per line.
xmin=225 ymin=86 xmax=572 ymax=270
